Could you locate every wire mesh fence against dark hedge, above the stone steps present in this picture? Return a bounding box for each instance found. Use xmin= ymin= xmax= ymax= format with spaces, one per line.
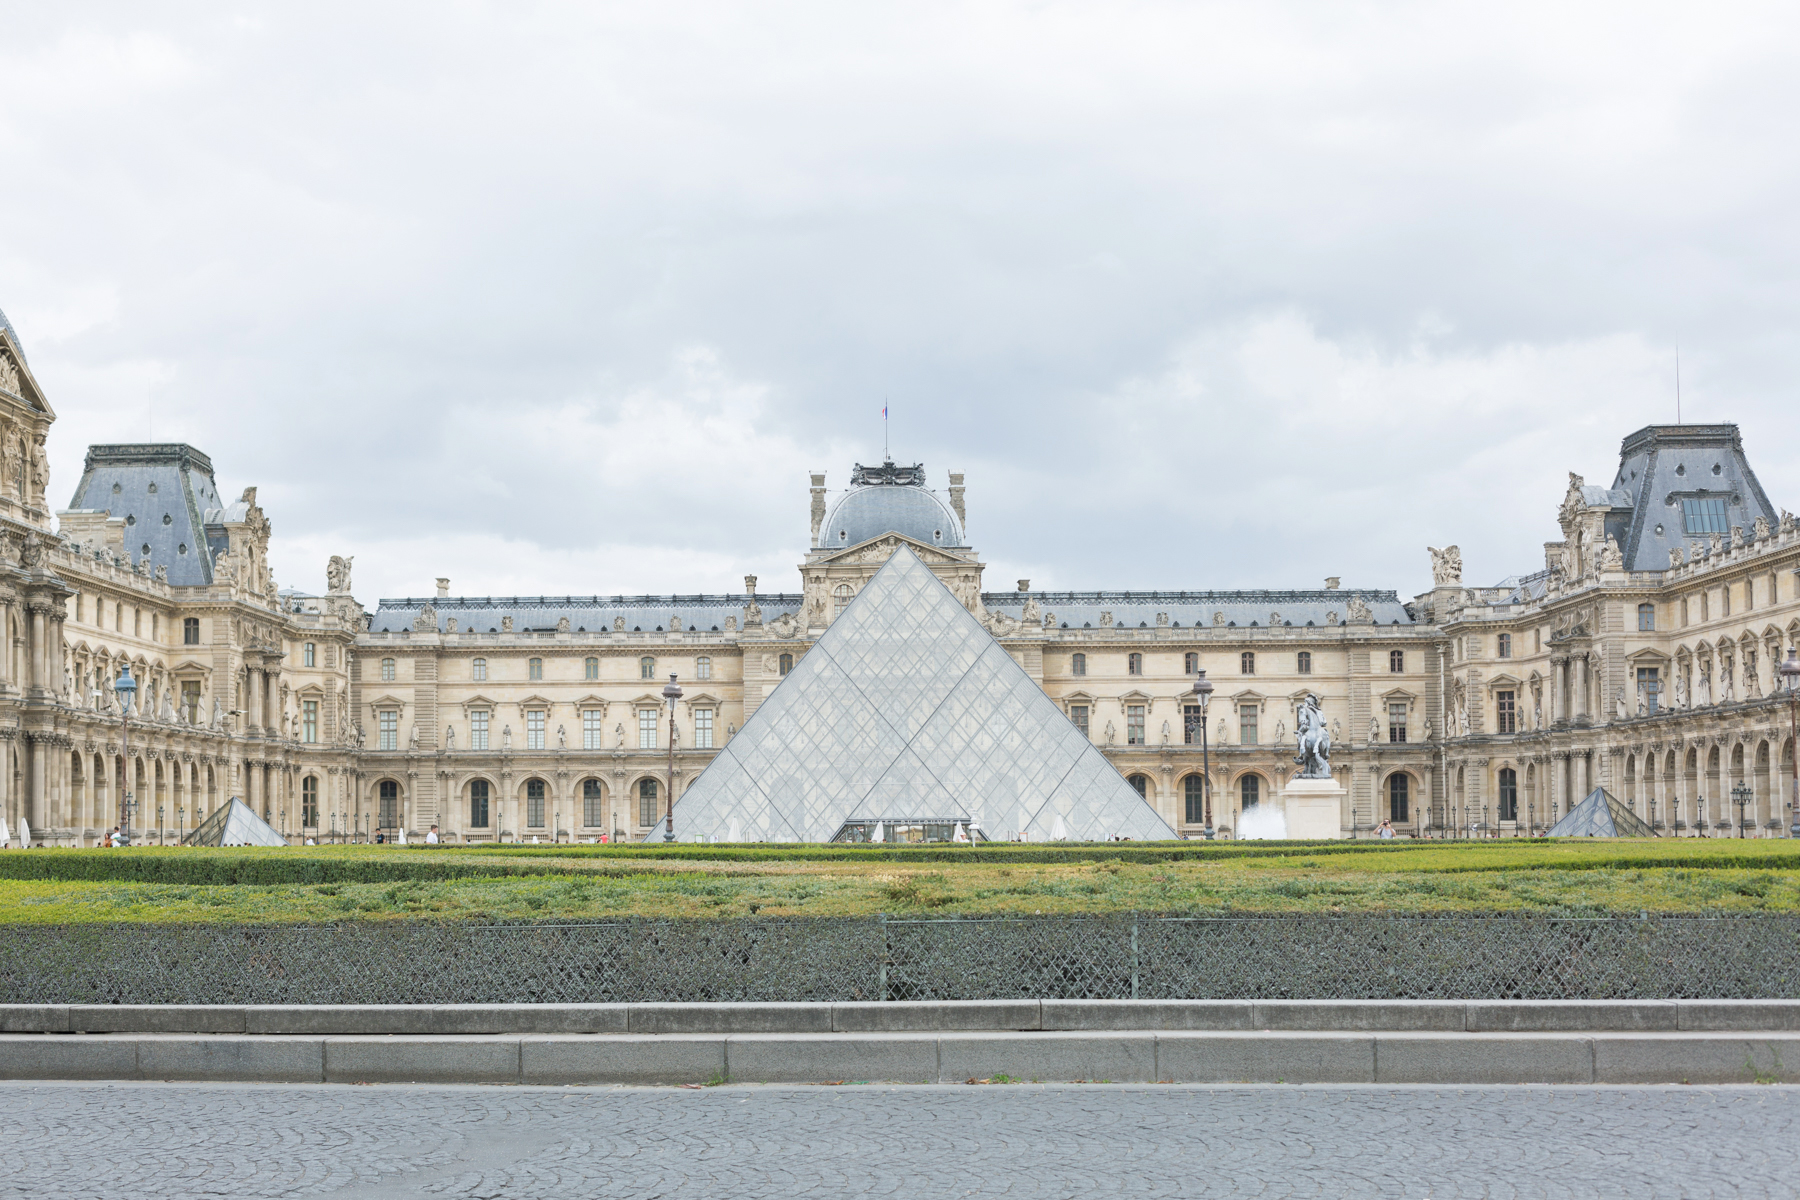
xmin=0 ymin=914 xmax=1800 ymax=1004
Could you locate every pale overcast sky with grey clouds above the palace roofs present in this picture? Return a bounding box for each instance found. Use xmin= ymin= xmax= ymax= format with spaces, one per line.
xmin=0 ymin=0 xmax=1800 ymax=603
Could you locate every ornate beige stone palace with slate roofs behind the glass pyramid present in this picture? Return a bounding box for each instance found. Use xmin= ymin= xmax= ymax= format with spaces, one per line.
xmin=0 ymin=305 xmax=1800 ymax=846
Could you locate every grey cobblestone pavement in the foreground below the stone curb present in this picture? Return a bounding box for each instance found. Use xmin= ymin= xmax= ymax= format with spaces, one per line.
xmin=0 ymin=1083 xmax=1800 ymax=1200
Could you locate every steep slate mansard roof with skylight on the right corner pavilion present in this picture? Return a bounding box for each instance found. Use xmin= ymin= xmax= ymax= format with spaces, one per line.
xmin=1612 ymin=425 xmax=1780 ymax=570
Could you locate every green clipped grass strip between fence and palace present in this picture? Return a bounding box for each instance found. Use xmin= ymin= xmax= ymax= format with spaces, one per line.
xmin=0 ymin=838 xmax=1800 ymax=925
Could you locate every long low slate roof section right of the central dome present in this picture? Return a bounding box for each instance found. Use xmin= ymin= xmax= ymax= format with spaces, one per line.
xmin=981 ymin=588 xmax=1413 ymax=630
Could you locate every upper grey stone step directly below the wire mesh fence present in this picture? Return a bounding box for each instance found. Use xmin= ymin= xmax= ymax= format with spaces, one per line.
xmin=0 ymin=1000 xmax=1800 ymax=1036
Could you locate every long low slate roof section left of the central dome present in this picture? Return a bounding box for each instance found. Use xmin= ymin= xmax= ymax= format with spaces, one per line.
xmin=369 ymin=594 xmax=801 ymax=633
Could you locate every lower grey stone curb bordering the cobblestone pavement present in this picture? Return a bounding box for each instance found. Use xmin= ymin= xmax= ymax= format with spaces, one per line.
xmin=0 ymin=1031 xmax=1800 ymax=1085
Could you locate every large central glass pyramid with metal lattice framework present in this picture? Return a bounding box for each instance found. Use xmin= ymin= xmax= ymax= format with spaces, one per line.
xmin=669 ymin=547 xmax=1175 ymax=842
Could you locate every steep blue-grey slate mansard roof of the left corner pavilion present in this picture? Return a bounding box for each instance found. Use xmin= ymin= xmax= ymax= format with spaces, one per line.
xmin=68 ymin=443 xmax=226 ymax=587
